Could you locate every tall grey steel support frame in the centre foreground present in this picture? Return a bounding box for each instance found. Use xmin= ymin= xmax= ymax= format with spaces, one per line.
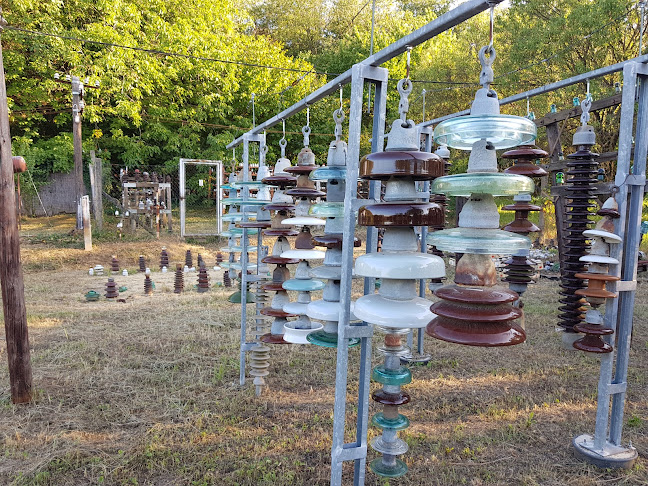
xmin=331 ymin=64 xmax=388 ymax=486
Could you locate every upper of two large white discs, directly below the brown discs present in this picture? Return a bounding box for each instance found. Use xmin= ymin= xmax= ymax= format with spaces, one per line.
xmin=355 ymin=252 xmax=445 ymax=279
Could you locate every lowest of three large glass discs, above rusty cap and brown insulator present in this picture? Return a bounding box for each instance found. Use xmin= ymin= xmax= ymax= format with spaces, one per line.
xmin=426 ymin=228 xmax=531 ymax=255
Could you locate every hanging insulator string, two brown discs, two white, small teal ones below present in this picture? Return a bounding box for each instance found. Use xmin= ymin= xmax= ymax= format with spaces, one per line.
xmin=353 ymin=79 xmax=445 ymax=477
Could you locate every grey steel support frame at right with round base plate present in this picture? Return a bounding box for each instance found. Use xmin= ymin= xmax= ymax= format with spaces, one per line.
xmin=573 ymin=56 xmax=648 ymax=467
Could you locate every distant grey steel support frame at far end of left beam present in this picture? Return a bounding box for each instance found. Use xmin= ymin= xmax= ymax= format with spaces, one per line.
xmin=239 ymin=133 xmax=265 ymax=386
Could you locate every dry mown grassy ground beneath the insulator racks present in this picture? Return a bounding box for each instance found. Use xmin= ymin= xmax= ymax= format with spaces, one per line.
xmin=0 ymin=218 xmax=648 ymax=486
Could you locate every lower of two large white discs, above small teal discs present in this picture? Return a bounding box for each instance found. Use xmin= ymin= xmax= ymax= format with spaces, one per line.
xmin=353 ymin=294 xmax=434 ymax=329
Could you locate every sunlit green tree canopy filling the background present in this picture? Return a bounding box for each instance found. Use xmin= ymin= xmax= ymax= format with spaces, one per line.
xmin=2 ymin=0 xmax=645 ymax=180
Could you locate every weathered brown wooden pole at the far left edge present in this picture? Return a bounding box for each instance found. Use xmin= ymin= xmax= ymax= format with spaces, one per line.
xmin=0 ymin=13 xmax=32 ymax=403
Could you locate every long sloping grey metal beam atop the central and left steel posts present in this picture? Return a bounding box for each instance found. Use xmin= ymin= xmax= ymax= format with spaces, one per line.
xmin=226 ymin=0 xmax=504 ymax=150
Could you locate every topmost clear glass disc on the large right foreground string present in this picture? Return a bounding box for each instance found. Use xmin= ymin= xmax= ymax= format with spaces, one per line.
xmin=434 ymin=115 xmax=537 ymax=150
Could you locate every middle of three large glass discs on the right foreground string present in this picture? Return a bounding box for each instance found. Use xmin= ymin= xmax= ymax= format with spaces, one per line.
xmin=430 ymin=172 xmax=535 ymax=197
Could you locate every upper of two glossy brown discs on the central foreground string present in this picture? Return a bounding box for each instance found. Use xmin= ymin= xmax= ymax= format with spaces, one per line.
xmin=360 ymin=151 xmax=445 ymax=181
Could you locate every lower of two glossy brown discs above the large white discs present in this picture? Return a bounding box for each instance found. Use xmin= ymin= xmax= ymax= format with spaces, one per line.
xmin=358 ymin=201 xmax=444 ymax=228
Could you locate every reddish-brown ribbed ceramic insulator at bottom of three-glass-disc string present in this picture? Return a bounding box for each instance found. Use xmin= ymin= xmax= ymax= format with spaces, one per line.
xmin=427 ymin=285 xmax=526 ymax=347
